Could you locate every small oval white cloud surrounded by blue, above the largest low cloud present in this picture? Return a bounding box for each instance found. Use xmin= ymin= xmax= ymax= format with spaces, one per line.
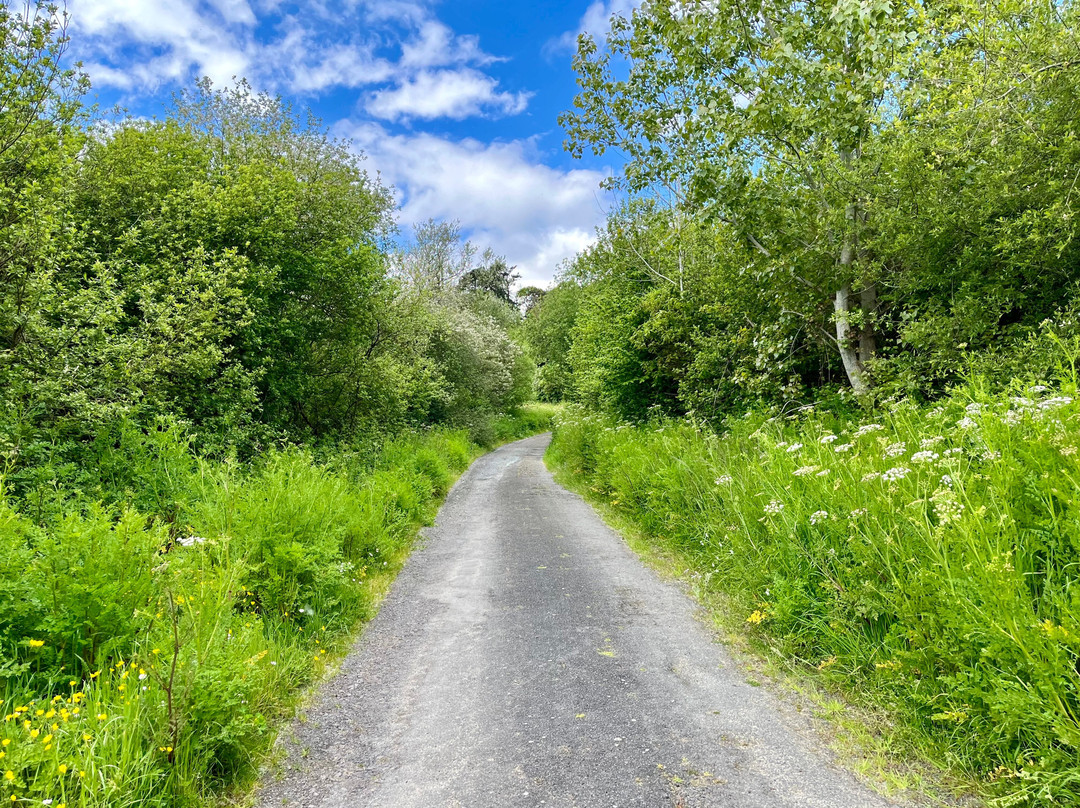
xmin=366 ymin=68 xmax=530 ymax=121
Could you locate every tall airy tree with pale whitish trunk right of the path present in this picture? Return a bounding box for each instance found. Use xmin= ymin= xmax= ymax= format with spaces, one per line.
xmin=561 ymin=0 xmax=936 ymax=393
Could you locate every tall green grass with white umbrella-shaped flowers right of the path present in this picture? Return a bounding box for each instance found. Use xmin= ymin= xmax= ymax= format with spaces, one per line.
xmin=551 ymin=383 xmax=1080 ymax=805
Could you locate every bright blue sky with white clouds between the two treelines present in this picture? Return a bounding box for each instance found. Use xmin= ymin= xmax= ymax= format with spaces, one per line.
xmin=67 ymin=0 xmax=637 ymax=285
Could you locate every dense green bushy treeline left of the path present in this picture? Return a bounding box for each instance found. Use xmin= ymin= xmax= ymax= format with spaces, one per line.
xmin=0 ymin=4 xmax=531 ymax=499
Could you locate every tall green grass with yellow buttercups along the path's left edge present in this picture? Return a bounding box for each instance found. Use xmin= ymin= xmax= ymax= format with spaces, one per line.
xmin=0 ymin=410 xmax=546 ymax=808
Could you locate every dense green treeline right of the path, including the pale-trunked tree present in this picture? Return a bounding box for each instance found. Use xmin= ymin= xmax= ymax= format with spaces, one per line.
xmin=528 ymin=0 xmax=1080 ymax=420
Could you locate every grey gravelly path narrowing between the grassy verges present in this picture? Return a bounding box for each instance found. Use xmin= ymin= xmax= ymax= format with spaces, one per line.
xmin=258 ymin=436 xmax=891 ymax=808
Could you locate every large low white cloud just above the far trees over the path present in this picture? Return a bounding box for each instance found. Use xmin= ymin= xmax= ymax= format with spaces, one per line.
xmin=343 ymin=121 xmax=606 ymax=285
